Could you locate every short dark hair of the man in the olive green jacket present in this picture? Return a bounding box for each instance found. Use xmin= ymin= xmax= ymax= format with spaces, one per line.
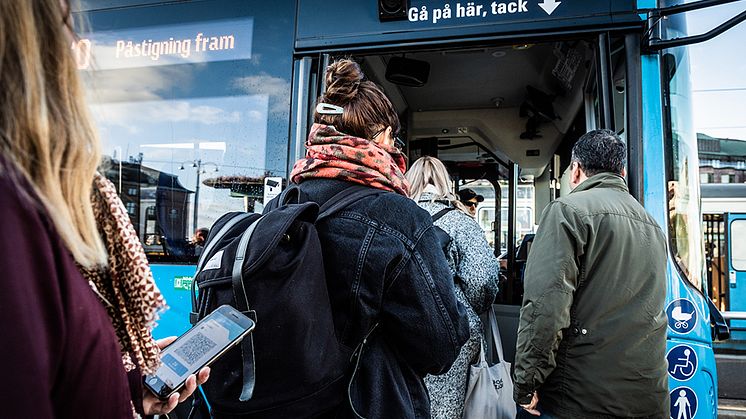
xmin=572 ymin=129 xmax=627 ymax=177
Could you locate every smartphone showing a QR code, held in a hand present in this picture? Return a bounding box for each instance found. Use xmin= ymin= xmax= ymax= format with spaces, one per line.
xmin=145 ymin=305 xmax=255 ymax=400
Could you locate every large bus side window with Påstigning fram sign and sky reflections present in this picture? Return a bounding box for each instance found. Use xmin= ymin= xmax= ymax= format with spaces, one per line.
xmin=79 ymin=0 xmax=294 ymax=262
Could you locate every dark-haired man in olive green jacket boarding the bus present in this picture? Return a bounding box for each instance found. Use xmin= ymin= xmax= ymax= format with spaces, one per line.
xmin=514 ymin=130 xmax=669 ymax=419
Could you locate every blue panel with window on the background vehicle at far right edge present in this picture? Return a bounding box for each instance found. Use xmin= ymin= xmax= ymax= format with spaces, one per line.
xmin=723 ymin=213 xmax=746 ymax=344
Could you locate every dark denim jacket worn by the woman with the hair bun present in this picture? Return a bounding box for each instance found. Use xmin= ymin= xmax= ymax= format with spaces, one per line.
xmin=300 ymin=179 xmax=469 ymax=418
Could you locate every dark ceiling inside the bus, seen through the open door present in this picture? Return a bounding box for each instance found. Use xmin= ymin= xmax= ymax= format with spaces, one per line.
xmin=348 ymin=37 xmax=604 ymax=179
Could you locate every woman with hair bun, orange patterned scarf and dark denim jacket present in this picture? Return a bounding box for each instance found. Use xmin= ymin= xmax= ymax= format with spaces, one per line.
xmin=284 ymin=59 xmax=469 ymax=418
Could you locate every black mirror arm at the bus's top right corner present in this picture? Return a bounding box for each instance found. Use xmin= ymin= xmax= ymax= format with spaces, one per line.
xmin=640 ymin=0 xmax=746 ymax=51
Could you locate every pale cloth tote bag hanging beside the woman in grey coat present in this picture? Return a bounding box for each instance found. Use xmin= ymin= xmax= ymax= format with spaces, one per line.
xmin=464 ymin=308 xmax=516 ymax=419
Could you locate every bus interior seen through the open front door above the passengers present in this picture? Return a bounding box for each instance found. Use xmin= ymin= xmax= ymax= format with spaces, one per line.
xmin=328 ymin=36 xmax=626 ymax=312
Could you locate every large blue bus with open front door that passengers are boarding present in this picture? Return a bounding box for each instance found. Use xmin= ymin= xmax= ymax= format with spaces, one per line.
xmin=72 ymin=0 xmax=746 ymax=419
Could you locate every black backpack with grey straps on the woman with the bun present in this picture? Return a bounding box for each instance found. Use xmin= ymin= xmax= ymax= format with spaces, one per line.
xmin=190 ymin=185 xmax=381 ymax=418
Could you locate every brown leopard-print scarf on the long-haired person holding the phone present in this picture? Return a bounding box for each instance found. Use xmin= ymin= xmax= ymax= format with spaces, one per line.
xmin=81 ymin=174 xmax=166 ymax=374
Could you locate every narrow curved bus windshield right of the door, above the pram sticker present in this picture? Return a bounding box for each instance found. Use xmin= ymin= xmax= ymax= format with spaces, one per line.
xmin=663 ymin=9 xmax=704 ymax=290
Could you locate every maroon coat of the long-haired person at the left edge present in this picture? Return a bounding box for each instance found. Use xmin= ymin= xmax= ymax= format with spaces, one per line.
xmin=0 ymin=162 xmax=132 ymax=419
